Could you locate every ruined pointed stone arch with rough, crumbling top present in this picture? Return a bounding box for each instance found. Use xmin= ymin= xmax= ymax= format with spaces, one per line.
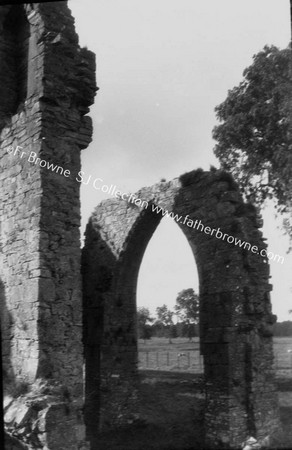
xmin=83 ymin=170 xmax=279 ymax=448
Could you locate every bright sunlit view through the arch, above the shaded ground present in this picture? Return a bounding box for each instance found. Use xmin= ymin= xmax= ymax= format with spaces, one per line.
xmin=137 ymin=218 xmax=203 ymax=372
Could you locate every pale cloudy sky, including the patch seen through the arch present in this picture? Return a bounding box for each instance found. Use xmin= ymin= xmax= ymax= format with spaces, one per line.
xmin=69 ymin=0 xmax=292 ymax=320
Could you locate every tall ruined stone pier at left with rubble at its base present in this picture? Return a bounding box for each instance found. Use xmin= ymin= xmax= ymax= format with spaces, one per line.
xmin=0 ymin=1 xmax=97 ymax=450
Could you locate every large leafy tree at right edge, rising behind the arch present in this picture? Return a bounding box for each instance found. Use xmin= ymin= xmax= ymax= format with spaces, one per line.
xmin=213 ymin=46 xmax=292 ymax=248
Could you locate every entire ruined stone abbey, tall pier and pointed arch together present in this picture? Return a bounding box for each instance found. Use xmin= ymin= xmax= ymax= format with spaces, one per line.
xmin=0 ymin=2 xmax=280 ymax=450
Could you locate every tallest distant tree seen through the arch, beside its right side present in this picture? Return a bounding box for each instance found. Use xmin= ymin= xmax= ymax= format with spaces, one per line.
xmin=174 ymin=288 xmax=199 ymax=341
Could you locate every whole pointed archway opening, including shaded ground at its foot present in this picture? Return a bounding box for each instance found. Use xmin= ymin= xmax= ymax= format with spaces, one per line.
xmin=131 ymin=218 xmax=204 ymax=448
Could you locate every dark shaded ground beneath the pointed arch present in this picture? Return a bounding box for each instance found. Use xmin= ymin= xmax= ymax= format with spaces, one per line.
xmin=92 ymin=371 xmax=203 ymax=450
